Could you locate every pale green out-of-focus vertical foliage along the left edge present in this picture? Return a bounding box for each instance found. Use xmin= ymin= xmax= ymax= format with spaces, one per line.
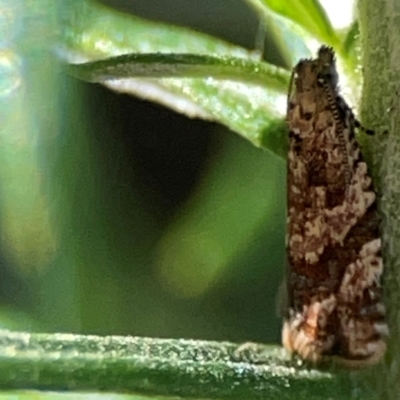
xmin=0 ymin=0 xmax=58 ymax=270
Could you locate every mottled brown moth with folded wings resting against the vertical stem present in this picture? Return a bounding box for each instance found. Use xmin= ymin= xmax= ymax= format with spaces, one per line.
xmin=282 ymin=46 xmax=388 ymax=368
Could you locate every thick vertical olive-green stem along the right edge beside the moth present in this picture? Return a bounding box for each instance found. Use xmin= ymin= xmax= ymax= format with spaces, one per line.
xmin=359 ymin=0 xmax=400 ymax=400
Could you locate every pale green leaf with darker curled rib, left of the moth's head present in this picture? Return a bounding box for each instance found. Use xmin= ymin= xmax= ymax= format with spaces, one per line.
xmin=60 ymin=2 xmax=289 ymax=154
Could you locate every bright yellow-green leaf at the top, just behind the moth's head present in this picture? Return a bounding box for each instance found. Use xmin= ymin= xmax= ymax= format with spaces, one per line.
xmin=245 ymin=0 xmax=361 ymax=106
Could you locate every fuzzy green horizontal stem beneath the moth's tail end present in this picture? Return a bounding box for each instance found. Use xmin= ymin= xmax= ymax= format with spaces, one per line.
xmin=0 ymin=330 xmax=371 ymax=400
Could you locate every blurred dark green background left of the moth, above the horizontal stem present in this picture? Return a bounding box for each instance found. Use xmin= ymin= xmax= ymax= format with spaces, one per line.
xmin=0 ymin=0 xmax=286 ymax=350
